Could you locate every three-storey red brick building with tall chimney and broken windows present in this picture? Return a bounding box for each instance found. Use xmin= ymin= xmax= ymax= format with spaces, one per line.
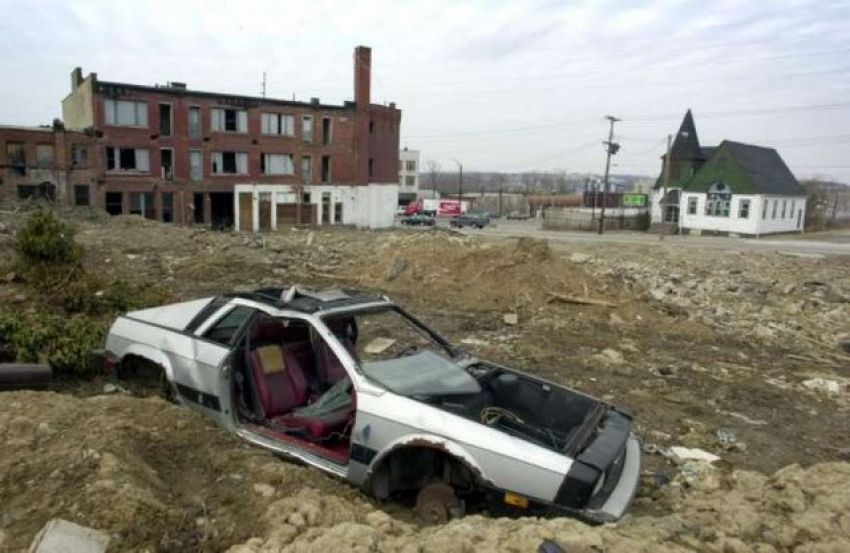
xmin=47 ymin=46 xmax=401 ymax=230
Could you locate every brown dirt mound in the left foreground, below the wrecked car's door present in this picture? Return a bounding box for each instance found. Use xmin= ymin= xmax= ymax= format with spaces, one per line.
xmin=0 ymin=392 xmax=356 ymax=551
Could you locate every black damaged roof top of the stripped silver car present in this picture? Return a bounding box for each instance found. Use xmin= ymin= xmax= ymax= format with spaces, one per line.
xmin=227 ymin=286 xmax=390 ymax=313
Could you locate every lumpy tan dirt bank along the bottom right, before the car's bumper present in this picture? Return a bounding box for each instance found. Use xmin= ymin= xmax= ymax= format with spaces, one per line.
xmin=229 ymin=463 xmax=850 ymax=553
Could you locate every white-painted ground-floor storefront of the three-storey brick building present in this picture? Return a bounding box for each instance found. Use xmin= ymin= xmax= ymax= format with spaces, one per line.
xmin=233 ymin=184 xmax=398 ymax=232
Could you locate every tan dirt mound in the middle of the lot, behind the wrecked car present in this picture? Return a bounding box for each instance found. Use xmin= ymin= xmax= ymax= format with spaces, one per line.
xmin=358 ymin=232 xmax=625 ymax=312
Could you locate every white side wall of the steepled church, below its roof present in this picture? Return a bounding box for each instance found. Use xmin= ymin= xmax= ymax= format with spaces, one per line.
xmin=680 ymin=192 xmax=806 ymax=235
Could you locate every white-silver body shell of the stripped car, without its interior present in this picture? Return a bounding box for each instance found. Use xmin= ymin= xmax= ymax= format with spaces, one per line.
xmin=106 ymin=290 xmax=640 ymax=522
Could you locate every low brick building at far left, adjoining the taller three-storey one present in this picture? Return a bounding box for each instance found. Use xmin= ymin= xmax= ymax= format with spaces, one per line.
xmin=0 ymin=121 xmax=97 ymax=206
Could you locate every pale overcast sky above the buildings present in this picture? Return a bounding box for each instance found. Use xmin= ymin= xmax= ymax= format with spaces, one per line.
xmin=0 ymin=0 xmax=850 ymax=182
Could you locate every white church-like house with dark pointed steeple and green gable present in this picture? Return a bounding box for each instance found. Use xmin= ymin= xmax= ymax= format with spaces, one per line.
xmin=652 ymin=110 xmax=806 ymax=236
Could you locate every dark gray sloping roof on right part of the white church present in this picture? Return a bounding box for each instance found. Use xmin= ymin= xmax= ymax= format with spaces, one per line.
xmin=718 ymin=140 xmax=806 ymax=196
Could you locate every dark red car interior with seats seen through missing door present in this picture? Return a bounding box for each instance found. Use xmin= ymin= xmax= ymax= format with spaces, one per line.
xmin=234 ymin=314 xmax=356 ymax=464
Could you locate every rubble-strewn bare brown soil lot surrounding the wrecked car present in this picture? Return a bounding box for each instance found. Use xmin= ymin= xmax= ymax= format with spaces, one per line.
xmin=0 ymin=205 xmax=850 ymax=551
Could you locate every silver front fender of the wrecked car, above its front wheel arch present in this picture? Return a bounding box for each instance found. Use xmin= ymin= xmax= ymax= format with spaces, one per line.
xmin=348 ymin=392 xmax=572 ymax=502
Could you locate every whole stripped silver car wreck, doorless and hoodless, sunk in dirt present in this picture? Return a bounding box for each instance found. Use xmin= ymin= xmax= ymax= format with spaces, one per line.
xmin=104 ymin=287 xmax=641 ymax=523
